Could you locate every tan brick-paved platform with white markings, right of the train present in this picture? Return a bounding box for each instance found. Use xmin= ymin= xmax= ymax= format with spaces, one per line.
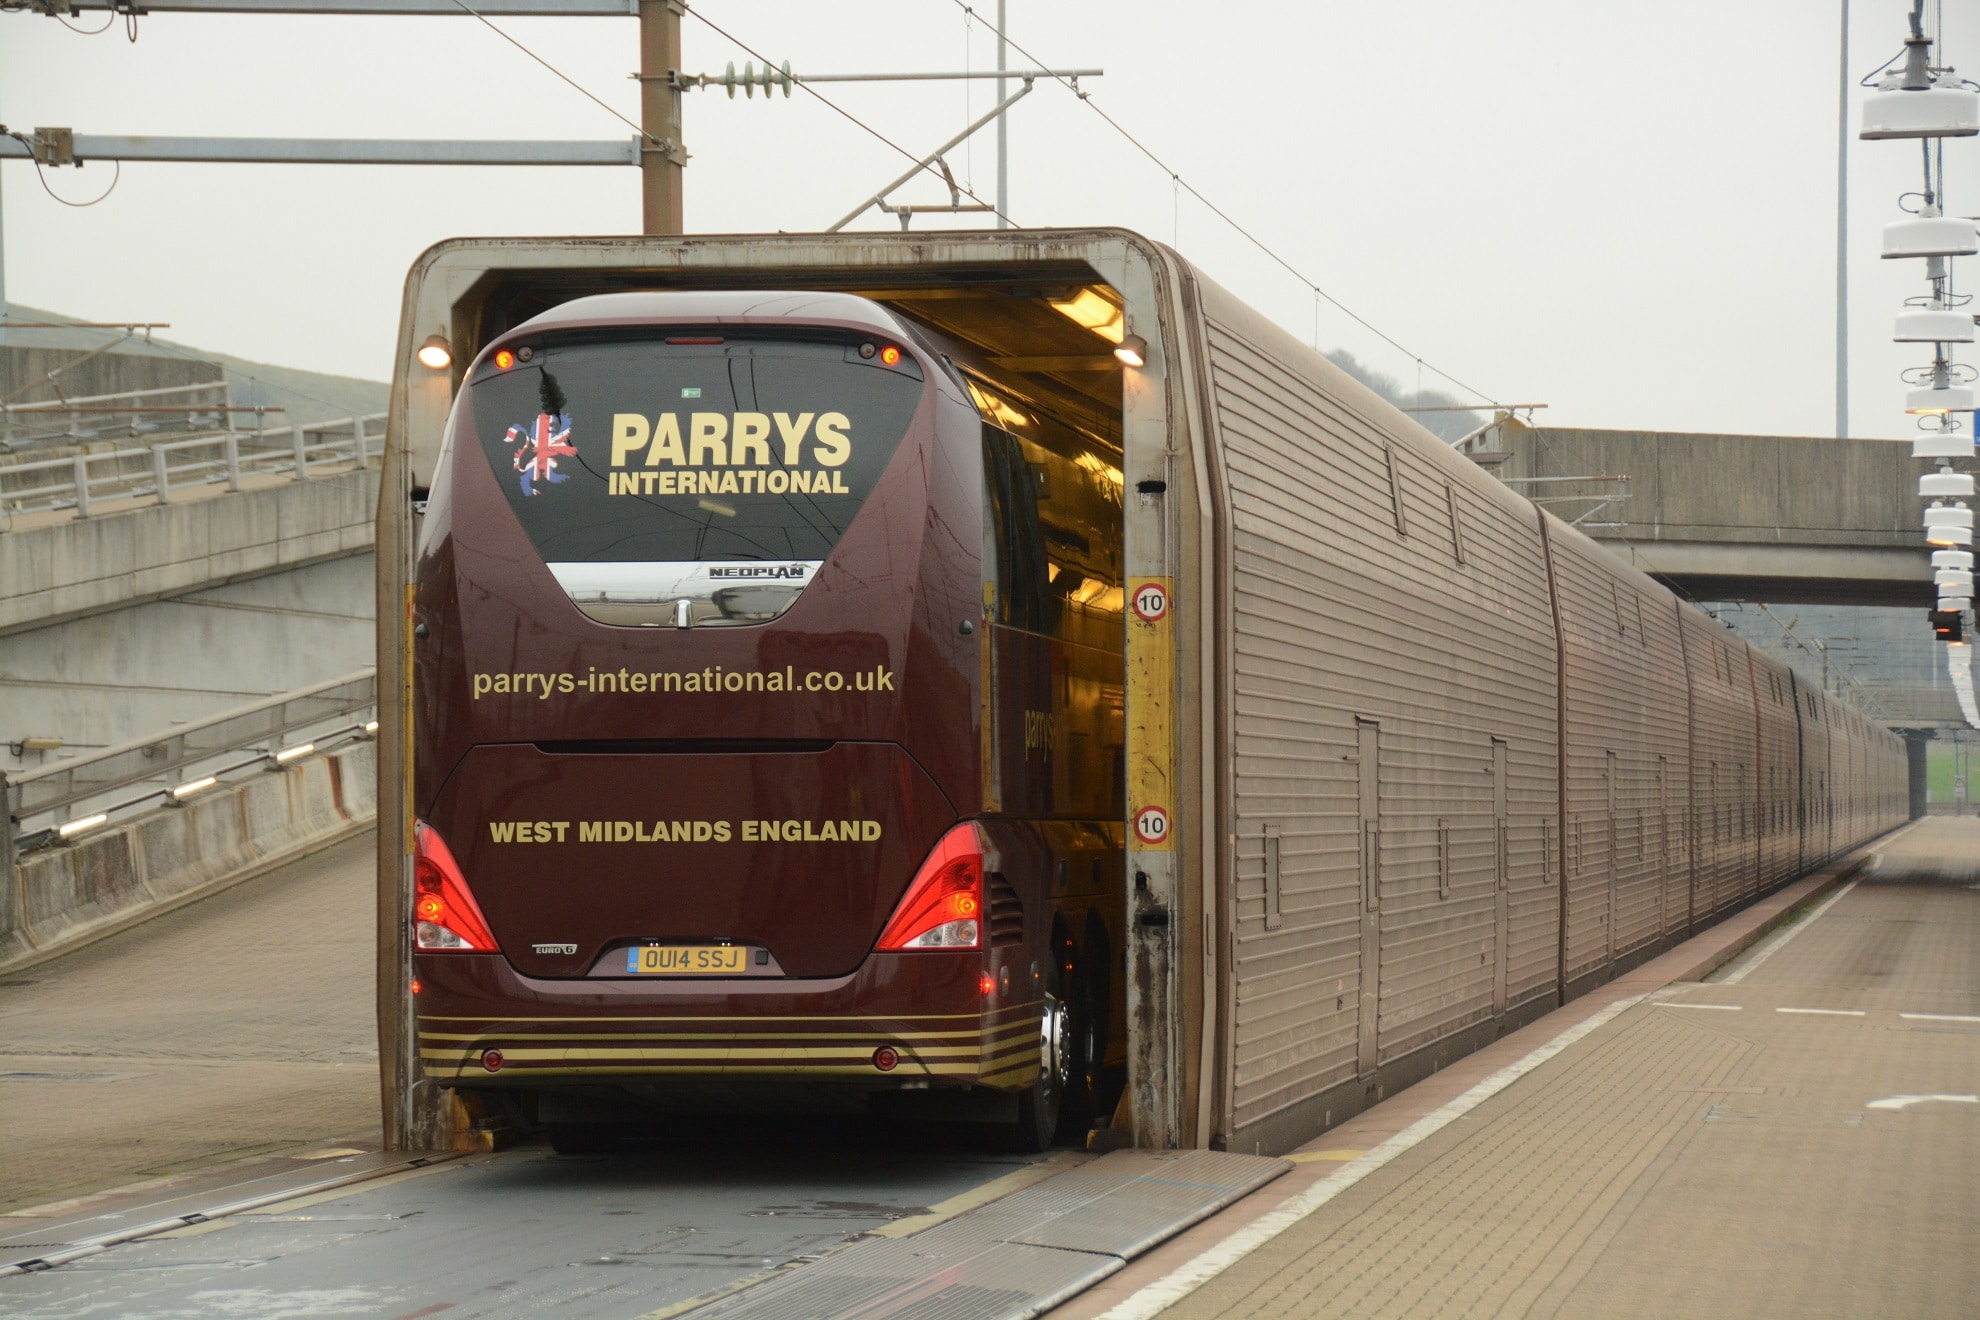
xmin=1051 ymin=819 xmax=1980 ymax=1320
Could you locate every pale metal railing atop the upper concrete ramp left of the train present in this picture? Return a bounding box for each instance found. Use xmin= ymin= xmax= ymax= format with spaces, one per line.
xmin=0 ymin=412 xmax=386 ymax=530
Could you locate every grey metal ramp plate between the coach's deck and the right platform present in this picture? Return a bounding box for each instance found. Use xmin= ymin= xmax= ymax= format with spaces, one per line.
xmin=691 ymin=1150 xmax=1293 ymax=1320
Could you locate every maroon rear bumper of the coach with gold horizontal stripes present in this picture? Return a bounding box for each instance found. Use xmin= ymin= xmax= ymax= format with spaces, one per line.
xmin=414 ymin=950 xmax=1041 ymax=1090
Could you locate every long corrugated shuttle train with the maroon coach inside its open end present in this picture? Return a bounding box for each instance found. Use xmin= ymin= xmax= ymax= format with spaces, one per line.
xmin=378 ymin=230 xmax=1907 ymax=1152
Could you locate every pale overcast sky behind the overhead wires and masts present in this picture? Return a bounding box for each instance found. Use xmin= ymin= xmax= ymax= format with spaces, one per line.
xmin=0 ymin=0 xmax=1980 ymax=435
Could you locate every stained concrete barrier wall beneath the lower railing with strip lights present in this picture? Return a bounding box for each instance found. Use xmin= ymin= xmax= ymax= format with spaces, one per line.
xmin=0 ymin=742 xmax=378 ymax=972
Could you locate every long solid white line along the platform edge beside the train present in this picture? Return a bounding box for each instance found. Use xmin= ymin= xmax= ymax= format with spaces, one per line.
xmin=1099 ymin=995 xmax=1645 ymax=1320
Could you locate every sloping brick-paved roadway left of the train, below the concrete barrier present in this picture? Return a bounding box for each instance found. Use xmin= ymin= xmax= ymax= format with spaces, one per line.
xmin=0 ymin=833 xmax=378 ymax=1235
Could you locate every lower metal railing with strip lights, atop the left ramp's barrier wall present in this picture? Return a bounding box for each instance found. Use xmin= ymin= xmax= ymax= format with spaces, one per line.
xmin=0 ymin=669 xmax=378 ymax=863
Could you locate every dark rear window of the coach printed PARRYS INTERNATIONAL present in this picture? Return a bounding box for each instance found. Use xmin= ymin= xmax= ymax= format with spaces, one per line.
xmin=469 ymin=336 xmax=923 ymax=564
